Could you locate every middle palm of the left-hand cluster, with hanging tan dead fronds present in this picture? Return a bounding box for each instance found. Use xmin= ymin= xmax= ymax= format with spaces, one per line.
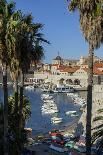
xmin=7 ymin=11 xmax=21 ymax=131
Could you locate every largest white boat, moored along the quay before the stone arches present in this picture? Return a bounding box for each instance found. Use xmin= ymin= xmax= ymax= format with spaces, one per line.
xmin=53 ymin=86 xmax=74 ymax=93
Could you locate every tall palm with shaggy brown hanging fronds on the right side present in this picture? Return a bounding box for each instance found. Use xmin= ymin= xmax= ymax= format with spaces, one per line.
xmin=69 ymin=0 xmax=103 ymax=155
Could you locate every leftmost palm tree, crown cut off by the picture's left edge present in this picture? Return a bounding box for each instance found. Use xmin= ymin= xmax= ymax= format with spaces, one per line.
xmin=0 ymin=0 xmax=15 ymax=155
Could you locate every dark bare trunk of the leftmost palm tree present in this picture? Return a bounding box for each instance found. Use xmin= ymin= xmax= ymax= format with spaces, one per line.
xmin=3 ymin=64 xmax=8 ymax=155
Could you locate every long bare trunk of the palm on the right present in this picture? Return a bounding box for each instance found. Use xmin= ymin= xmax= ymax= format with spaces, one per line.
xmin=86 ymin=46 xmax=94 ymax=155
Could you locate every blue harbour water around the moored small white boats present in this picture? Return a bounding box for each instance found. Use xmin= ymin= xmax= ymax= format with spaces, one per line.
xmin=0 ymin=88 xmax=86 ymax=135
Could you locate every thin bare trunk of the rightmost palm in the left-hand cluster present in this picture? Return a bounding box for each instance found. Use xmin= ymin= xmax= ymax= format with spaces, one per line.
xmin=19 ymin=73 xmax=24 ymax=129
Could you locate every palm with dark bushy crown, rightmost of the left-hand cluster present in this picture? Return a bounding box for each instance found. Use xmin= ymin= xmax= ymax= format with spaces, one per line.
xmin=14 ymin=15 xmax=48 ymax=136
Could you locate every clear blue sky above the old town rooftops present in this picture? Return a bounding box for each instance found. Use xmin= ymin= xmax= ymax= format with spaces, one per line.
xmin=8 ymin=0 xmax=103 ymax=63
